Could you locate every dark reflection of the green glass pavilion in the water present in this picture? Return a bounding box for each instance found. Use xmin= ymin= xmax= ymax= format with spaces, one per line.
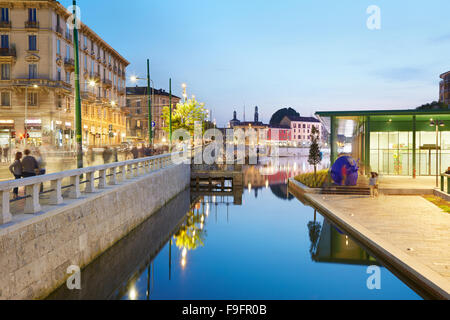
xmin=308 ymin=220 xmax=378 ymax=265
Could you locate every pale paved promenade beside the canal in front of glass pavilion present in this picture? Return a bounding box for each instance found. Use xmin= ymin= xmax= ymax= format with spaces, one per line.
xmin=305 ymin=194 xmax=450 ymax=299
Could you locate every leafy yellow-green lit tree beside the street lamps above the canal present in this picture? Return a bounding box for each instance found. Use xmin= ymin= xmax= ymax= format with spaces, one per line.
xmin=162 ymin=99 xmax=207 ymax=134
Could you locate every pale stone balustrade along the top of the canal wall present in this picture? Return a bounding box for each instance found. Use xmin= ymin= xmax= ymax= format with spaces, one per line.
xmin=0 ymin=152 xmax=182 ymax=225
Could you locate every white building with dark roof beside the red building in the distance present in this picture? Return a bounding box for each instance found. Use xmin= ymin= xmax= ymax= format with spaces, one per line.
xmin=280 ymin=116 xmax=323 ymax=146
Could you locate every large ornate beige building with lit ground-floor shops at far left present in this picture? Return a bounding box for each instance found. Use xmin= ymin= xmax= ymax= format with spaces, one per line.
xmin=0 ymin=0 xmax=129 ymax=149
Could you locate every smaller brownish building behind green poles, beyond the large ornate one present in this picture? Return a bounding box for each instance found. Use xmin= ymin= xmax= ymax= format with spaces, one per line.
xmin=126 ymin=86 xmax=181 ymax=144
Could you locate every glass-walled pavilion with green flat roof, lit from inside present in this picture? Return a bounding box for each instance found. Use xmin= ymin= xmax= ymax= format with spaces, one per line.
xmin=317 ymin=110 xmax=450 ymax=177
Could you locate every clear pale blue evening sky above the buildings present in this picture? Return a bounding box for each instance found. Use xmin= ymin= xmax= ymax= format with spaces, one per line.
xmin=60 ymin=0 xmax=450 ymax=125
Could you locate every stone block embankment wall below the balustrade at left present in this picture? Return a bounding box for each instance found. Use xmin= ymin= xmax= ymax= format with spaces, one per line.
xmin=0 ymin=165 xmax=190 ymax=299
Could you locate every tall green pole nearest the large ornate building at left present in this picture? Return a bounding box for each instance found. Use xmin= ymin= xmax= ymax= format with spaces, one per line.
xmin=72 ymin=0 xmax=83 ymax=168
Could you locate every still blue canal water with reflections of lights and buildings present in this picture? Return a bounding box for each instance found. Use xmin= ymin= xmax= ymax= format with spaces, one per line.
xmin=50 ymin=158 xmax=421 ymax=300
